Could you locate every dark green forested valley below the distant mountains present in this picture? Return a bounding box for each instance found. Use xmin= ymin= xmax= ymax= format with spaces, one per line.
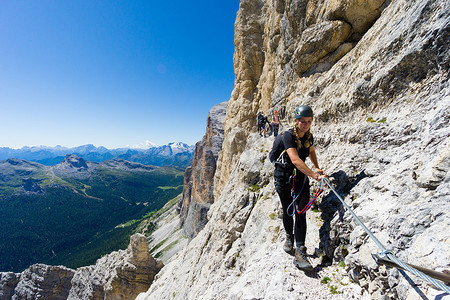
xmin=0 ymin=155 xmax=184 ymax=272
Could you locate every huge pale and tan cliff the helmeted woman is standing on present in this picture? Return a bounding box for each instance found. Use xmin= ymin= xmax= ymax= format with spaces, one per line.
xmin=142 ymin=0 xmax=450 ymax=300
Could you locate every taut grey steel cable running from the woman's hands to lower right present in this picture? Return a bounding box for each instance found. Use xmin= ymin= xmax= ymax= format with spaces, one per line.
xmin=323 ymin=178 xmax=450 ymax=294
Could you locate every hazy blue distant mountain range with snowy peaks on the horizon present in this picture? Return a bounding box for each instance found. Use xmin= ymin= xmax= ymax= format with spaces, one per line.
xmin=0 ymin=142 xmax=195 ymax=169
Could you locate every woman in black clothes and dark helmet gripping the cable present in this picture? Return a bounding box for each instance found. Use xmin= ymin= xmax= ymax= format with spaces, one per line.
xmin=274 ymin=105 xmax=326 ymax=271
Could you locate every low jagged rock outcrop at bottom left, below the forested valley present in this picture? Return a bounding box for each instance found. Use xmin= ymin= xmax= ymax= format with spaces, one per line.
xmin=0 ymin=234 xmax=162 ymax=300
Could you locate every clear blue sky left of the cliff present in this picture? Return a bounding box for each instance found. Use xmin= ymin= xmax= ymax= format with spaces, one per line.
xmin=0 ymin=0 xmax=239 ymax=148
